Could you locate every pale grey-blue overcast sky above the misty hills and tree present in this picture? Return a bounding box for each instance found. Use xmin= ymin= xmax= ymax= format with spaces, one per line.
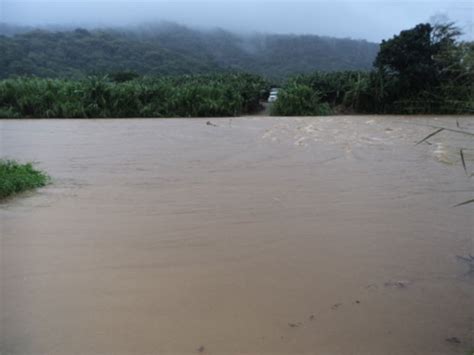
xmin=0 ymin=0 xmax=474 ymax=42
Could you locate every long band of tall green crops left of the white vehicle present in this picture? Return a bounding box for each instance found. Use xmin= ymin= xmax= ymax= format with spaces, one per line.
xmin=0 ymin=74 xmax=267 ymax=118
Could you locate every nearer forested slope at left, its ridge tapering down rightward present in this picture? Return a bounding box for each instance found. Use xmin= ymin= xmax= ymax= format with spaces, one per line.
xmin=0 ymin=29 xmax=215 ymax=78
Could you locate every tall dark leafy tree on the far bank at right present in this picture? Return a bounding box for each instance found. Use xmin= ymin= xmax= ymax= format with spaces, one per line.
xmin=375 ymin=24 xmax=474 ymax=113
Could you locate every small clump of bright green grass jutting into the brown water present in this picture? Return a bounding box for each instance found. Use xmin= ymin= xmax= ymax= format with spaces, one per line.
xmin=0 ymin=160 xmax=49 ymax=200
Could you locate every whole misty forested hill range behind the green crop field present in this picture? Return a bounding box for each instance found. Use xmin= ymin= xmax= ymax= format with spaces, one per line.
xmin=0 ymin=23 xmax=379 ymax=79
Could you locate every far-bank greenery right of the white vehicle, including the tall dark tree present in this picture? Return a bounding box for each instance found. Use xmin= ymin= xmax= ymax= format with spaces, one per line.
xmin=275 ymin=24 xmax=474 ymax=115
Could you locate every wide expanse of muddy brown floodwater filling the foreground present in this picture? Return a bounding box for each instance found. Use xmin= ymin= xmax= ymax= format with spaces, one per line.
xmin=0 ymin=116 xmax=474 ymax=355
